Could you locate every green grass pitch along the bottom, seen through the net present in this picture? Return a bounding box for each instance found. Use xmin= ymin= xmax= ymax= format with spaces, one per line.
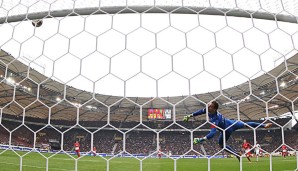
xmin=0 ymin=150 xmax=297 ymax=171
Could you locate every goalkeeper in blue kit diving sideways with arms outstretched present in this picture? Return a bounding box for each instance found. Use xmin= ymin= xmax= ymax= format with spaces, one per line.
xmin=183 ymin=101 xmax=272 ymax=161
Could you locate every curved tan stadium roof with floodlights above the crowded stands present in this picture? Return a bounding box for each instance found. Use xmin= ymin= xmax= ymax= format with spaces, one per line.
xmin=0 ymin=48 xmax=298 ymax=121
